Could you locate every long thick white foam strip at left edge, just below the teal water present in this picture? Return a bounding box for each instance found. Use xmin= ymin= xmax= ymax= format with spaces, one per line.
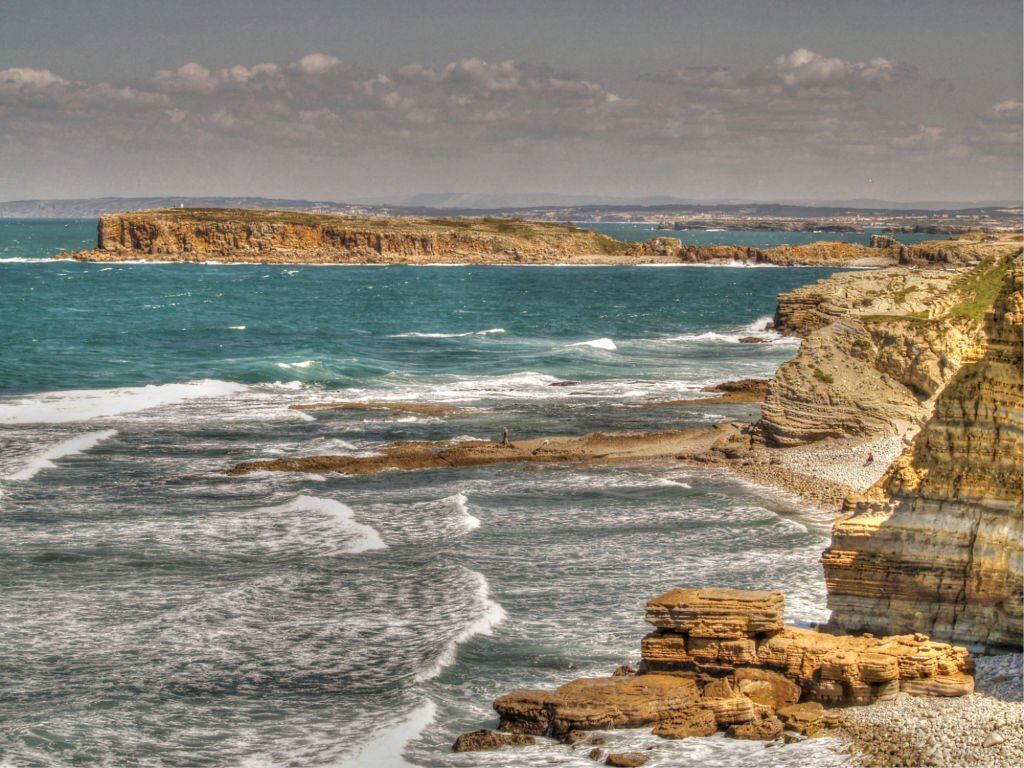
xmin=0 ymin=379 xmax=246 ymax=424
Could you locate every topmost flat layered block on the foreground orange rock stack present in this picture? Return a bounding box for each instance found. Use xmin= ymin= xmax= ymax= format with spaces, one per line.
xmin=646 ymin=587 xmax=784 ymax=639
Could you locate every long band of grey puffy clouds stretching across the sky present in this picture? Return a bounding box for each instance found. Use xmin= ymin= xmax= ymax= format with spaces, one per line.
xmin=0 ymin=48 xmax=1021 ymax=201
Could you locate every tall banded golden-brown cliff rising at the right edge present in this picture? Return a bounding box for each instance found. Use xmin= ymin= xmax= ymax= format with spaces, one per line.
xmin=822 ymin=258 xmax=1024 ymax=649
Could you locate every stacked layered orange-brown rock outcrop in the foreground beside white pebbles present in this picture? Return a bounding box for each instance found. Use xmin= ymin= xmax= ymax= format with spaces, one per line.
xmin=479 ymin=588 xmax=974 ymax=753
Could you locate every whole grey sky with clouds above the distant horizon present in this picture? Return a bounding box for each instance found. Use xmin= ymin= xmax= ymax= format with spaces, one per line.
xmin=0 ymin=0 xmax=1022 ymax=202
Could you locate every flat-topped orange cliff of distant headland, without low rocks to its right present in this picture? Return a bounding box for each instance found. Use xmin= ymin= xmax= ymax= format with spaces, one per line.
xmin=77 ymin=209 xmax=628 ymax=263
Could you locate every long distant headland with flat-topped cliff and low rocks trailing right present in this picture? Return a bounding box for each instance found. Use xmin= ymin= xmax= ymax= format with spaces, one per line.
xmin=68 ymin=208 xmax=1010 ymax=267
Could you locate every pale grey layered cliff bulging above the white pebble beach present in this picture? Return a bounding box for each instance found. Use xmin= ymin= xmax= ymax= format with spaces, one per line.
xmin=759 ymin=268 xmax=981 ymax=446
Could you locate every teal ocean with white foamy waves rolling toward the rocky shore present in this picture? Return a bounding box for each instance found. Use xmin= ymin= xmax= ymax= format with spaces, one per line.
xmin=0 ymin=221 xmax=892 ymax=768
